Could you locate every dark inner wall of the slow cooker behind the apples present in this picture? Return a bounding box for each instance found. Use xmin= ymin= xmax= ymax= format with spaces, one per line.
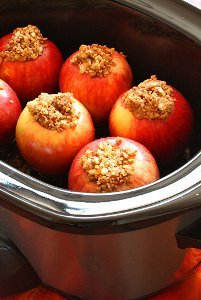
xmin=0 ymin=0 xmax=201 ymax=184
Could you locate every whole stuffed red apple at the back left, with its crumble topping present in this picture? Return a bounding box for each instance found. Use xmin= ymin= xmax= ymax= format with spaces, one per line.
xmin=0 ymin=25 xmax=63 ymax=104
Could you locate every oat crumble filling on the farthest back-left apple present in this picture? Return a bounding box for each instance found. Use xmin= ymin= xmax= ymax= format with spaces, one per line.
xmin=0 ymin=25 xmax=47 ymax=62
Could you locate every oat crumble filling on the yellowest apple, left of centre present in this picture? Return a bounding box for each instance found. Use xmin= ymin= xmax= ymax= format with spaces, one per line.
xmin=27 ymin=93 xmax=80 ymax=131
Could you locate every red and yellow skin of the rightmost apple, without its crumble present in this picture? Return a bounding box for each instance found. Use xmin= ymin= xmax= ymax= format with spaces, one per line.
xmin=109 ymin=88 xmax=193 ymax=163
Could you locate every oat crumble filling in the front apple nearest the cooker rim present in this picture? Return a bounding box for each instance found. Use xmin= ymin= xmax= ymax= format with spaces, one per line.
xmin=80 ymin=138 xmax=137 ymax=192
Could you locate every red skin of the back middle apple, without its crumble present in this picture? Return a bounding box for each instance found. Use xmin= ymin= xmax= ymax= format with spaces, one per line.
xmin=59 ymin=51 xmax=133 ymax=124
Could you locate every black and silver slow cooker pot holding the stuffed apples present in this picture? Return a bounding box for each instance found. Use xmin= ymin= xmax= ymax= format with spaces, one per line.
xmin=0 ymin=0 xmax=201 ymax=300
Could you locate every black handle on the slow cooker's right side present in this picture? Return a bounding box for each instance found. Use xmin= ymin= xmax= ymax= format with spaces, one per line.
xmin=176 ymin=218 xmax=201 ymax=249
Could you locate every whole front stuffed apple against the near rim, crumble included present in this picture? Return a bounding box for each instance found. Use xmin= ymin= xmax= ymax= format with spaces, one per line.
xmin=68 ymin=137 xmax=159 ymax=193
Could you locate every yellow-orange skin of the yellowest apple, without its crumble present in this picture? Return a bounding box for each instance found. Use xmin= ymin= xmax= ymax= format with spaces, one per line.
xmin=16 ymin=100 xmax=95 ymax=175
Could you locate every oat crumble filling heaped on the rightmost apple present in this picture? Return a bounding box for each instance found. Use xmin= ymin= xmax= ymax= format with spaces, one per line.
xmin=124 ymin=75 xmax=175 ymax=120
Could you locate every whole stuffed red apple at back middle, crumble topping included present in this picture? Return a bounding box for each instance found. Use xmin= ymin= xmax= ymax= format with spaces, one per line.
xmin=59 ymin=44 xmax=133 ymax=123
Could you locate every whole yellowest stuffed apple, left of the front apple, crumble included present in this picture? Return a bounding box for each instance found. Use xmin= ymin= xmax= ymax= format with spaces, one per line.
xmin=16 ymin=93 xmax=95 ymax=175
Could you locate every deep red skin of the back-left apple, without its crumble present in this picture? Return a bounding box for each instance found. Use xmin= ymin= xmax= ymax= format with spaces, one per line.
xmin=0 ymin=33 xmax=64 ymax=105
